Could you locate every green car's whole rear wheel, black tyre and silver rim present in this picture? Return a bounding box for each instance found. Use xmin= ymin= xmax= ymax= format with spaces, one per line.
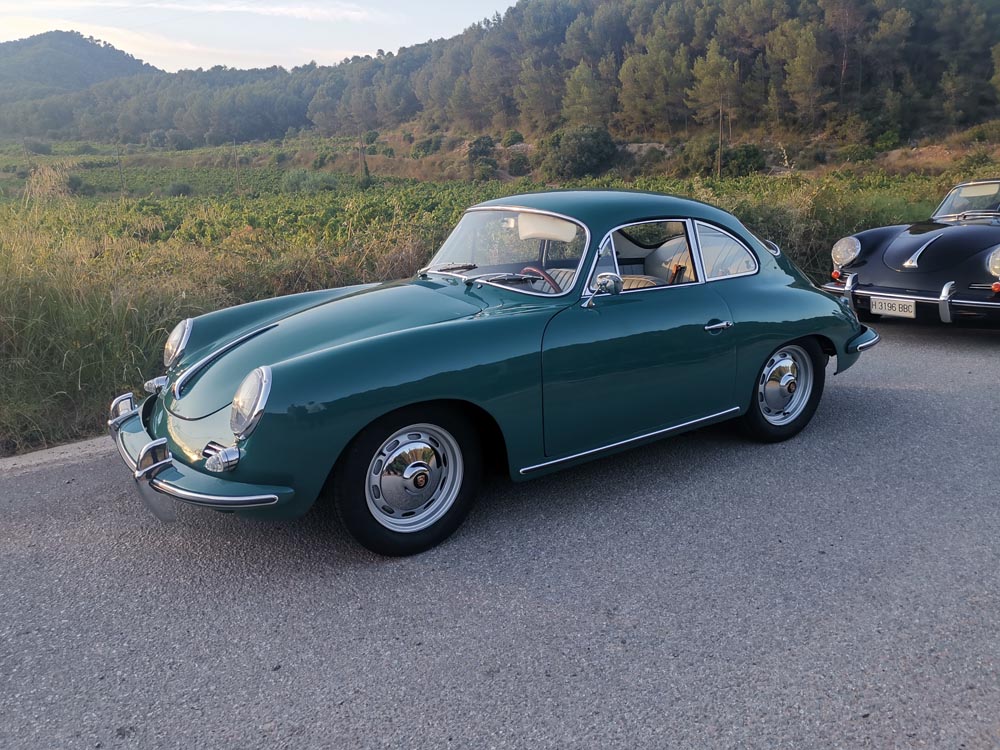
xmin=742 ymin=339 xmax=827 ymax=443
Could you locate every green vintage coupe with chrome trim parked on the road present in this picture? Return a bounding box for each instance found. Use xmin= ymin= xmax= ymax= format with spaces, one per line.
xmin=109 ymin=191 xmax=878 ymax=555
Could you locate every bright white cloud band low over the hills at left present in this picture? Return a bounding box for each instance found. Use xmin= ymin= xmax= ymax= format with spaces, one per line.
xmin=0 ymin=16 xmax=369 ymax=71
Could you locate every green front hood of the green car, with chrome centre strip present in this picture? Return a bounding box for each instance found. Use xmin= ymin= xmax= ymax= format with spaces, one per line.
xmin=164 ymin=280 xmax=482 ymax=419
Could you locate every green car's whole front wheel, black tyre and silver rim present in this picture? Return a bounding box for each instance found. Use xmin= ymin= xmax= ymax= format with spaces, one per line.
xmin=333 ymin=406 xmax=482 ymax=556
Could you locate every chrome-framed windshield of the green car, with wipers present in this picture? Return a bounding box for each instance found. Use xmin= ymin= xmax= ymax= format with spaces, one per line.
xmin=421 ymin=209 xmax=587 ymax=295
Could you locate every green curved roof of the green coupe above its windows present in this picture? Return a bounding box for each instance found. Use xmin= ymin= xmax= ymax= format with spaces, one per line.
xmin=476 ymin=190 xmax=742 ymax=240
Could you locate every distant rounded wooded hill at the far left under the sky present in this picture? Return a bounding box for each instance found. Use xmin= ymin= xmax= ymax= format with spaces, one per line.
xmin=0 ymin=31 xmax=159 ymax=103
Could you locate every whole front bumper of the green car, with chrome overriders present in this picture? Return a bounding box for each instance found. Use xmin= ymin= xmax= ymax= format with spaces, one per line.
xmin=108 ymin=393 xmax=295 ymax=521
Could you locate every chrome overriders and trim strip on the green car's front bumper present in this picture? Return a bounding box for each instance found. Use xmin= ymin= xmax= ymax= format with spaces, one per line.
xmin=108 ymin=393 xmax=278 ymax=521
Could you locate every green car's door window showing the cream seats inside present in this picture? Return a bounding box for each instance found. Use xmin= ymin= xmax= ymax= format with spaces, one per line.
xmin=612 ymin=221 xmax=698 ymax=291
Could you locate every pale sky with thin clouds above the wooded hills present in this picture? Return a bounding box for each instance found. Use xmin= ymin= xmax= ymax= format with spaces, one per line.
xmin=0 ymin=0 xmax=514 ymax=71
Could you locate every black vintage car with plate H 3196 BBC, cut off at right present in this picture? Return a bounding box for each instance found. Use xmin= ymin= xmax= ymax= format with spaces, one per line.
xmin=823 ymin=180 xmax=1000 ymax=323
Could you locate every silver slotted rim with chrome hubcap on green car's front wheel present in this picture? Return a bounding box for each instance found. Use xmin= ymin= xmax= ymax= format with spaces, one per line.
xmin=365 ymin=424 xmax=462 ymax=533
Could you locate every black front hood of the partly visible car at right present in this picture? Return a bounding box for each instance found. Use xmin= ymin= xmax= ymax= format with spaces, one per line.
xmin=882 ymin=221 xmax=1000 ymax=273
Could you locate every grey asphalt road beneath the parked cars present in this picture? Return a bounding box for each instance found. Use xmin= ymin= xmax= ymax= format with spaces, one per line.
xmin=0 ymin=322 xmax=1000 ymax=750
